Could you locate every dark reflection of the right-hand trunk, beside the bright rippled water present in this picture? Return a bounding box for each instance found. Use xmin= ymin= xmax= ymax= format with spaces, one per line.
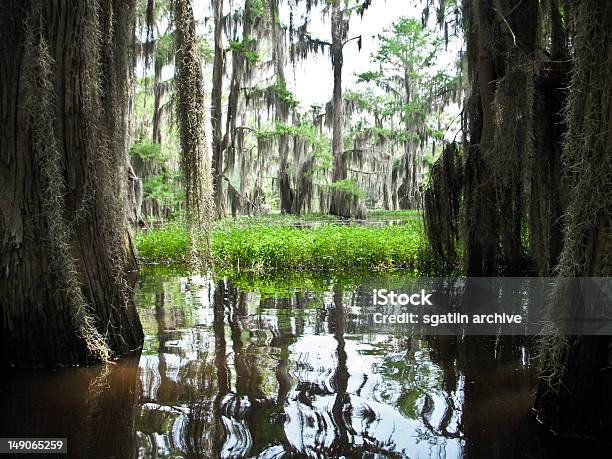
xmin=422 ymin=336 xmax=536 ymax=457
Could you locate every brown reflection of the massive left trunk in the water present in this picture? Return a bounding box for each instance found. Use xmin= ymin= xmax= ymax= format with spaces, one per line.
xmin=0 ymin=357 xmax=140 ymax=458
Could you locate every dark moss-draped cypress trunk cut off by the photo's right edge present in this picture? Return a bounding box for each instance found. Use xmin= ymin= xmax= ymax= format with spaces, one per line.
xmin=536 ymin=0 xmax=612 ymax=443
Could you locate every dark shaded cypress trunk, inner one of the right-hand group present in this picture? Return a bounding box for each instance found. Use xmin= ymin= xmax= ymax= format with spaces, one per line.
xmin=463 ymin=0 xmax=536 ymax=276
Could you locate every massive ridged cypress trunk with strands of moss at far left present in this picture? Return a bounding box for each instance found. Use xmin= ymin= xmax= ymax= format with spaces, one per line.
xmin=0 ymin=0 xmax=143 ymax=366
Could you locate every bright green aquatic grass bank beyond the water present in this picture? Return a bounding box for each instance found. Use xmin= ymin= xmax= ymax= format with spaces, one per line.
xmin=136 ymin=219 xmax=423 ymax=272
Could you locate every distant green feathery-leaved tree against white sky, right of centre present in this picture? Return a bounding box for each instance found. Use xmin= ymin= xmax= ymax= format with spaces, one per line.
xmin=359 ymin=18 xmax=461 ymax=208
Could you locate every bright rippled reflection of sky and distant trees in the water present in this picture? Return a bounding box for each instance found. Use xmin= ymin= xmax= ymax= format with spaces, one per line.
xmin=138 ymin=277 xmax=502 ymax=457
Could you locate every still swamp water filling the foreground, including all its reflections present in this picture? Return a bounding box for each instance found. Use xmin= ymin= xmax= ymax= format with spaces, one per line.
xmin=0 ymin=269 xmax=610 ymax=458
